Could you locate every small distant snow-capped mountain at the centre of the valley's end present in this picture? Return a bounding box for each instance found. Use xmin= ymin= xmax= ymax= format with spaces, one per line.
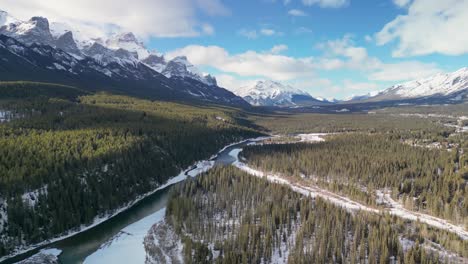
xmin=234 ymin=80 xmax=325 ymax=107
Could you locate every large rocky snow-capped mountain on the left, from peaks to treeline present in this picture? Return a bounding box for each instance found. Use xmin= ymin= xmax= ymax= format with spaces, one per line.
xmin=0 ymin=12 xmax=248 ymax=106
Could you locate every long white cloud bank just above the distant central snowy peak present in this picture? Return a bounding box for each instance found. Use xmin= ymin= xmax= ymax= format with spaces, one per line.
xmin=166 ymin=45 xmax=315 ymax=81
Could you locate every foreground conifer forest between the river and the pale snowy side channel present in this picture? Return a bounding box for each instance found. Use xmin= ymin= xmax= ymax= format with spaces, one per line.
xmin=155 ymin=167 xmax=442 ymax=263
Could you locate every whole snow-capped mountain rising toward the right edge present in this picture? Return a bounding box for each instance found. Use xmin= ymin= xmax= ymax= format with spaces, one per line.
xmin=352 ymin=68 xmax=468 ymax=101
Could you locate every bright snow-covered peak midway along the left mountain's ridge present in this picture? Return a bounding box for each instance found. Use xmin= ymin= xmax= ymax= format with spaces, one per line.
xmin=106 ymin=32 xmax=151 ymax=60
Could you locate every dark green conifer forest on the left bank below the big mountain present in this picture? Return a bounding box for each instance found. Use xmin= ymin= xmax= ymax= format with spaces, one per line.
xmin=0 ymin=82 xmax=259 ymax=255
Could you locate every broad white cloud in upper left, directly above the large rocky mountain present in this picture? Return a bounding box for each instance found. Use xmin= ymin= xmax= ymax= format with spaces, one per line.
xmin=0 ymin=0 xmax=229 ymax=37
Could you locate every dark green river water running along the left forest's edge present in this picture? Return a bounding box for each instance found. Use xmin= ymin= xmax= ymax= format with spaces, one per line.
xmin=2 ymin=140 xmax=255 ymax=264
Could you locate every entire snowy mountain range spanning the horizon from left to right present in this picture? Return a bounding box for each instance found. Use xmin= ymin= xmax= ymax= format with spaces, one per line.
xmin=0 ymin=11 xmax=468 ymax=108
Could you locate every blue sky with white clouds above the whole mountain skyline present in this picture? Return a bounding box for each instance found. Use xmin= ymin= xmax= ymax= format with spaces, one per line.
xmin=0 ymin=0 xmax=468 ymax=98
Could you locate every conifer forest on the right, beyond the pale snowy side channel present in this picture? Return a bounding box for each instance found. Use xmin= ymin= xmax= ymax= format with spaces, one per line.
xmin=242 ymin=134 xmax=468 ymax=226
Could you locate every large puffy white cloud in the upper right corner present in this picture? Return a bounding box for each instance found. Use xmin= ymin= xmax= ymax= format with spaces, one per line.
xmin=376 ymin=0 xmax=468 ymax=57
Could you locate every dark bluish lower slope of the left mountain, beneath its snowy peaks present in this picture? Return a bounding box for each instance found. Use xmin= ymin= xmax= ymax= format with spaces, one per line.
xmin=0 ymin=35 xmax=248 ymax=106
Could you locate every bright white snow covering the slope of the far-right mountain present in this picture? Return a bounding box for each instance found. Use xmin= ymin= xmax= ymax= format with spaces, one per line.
xmin=380 ymin=68 xmax=468 ymax=98
